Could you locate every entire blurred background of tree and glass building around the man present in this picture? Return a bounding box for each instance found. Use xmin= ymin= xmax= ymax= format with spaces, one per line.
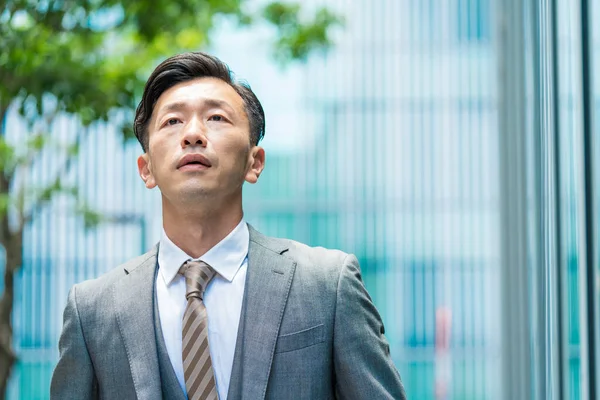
xmin=0 ymin=0 xmax=600 ymax=399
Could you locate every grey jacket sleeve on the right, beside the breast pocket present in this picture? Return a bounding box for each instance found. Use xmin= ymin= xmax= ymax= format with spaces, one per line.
xmin=333 ymin=255 xmax=406 ymax=400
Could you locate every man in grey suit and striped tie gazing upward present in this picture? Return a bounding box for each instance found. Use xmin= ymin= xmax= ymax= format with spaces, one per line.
xmin=51 ymin=53 xmax=405 ymax=400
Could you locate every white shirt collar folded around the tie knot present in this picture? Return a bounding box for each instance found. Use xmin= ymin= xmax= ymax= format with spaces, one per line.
xmin=158 ymin=219 xmax=250 ymax=286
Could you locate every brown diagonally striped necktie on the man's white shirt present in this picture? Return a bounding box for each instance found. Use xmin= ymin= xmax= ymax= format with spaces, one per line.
xmin=179 ymin=261 xmax=219 ymax=400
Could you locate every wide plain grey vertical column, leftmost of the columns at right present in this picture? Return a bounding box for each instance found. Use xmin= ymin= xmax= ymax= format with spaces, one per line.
xmin=497 ymin=0 xmax=532 ymax=399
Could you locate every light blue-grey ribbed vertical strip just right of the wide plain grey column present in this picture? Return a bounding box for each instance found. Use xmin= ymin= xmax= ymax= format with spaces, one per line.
xmin=531 ymin=0 xmax=564 ymax=400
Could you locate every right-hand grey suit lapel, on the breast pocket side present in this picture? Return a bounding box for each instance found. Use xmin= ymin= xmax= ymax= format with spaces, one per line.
xmin=228 ymin=226 xmax=296 ymax=399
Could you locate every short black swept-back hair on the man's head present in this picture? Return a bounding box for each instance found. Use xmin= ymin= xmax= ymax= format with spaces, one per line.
xmin=133 ymin=51 xmax=265 ymax=152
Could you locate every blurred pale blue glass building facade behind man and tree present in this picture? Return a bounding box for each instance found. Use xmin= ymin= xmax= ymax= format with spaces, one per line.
xmin=4 ymin=0 xmax=600 ymax=399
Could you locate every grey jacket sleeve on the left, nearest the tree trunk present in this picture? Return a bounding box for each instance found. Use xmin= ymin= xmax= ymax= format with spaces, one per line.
xmin=50 ymin=286 xmax=98 ymax=400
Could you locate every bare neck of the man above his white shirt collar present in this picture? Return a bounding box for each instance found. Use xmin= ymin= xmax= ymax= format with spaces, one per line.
xmin=163 ymin=197 xmax=244 ymax=258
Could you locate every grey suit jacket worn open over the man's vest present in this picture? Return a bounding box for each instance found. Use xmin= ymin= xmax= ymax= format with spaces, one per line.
xmin=50 ymin=227 xmax=405 ymax=400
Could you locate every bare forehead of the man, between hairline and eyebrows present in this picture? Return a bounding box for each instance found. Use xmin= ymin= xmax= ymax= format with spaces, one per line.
xmin=153 ymin=78 xmax=244 ymax=114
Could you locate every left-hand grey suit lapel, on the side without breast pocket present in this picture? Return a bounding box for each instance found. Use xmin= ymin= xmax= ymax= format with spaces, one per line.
xmin=113 ymin=247 xmax=161 ymax=400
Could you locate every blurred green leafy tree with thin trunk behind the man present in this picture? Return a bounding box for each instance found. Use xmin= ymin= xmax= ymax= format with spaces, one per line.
xmin=0 ymin=0 xmax=340 ymax=399
